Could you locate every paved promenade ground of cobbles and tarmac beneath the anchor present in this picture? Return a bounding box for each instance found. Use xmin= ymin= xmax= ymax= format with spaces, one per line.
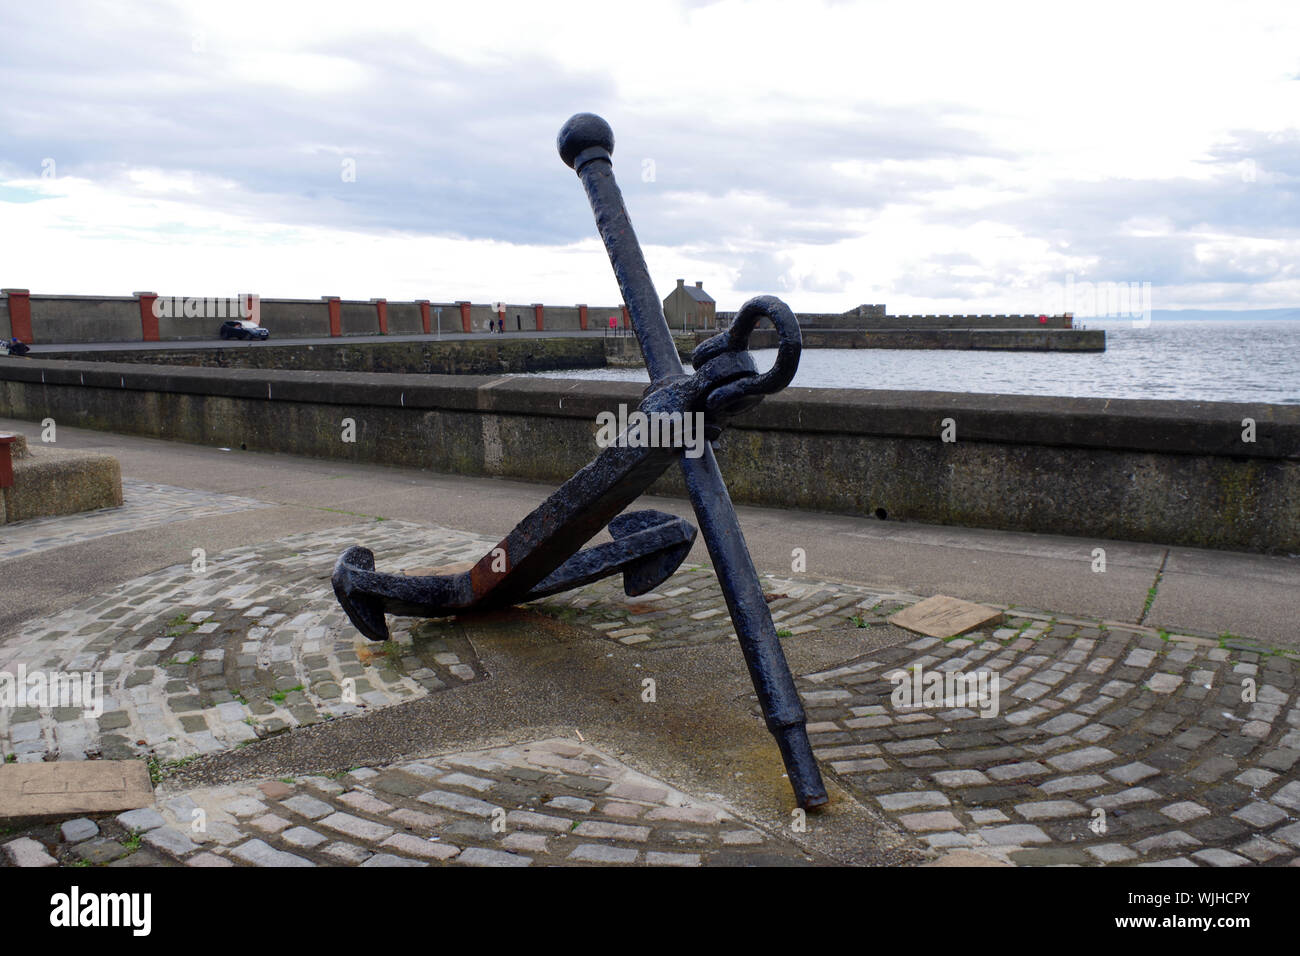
xmin=0 ymin=418 xmax=1300 ymax=866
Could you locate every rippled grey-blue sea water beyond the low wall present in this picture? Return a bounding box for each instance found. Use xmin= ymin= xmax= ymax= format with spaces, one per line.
xmin=536 ymin=319 xmax=1300 ymax=405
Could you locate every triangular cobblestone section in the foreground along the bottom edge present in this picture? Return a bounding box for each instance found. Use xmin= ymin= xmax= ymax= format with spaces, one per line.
xmin=0 ymin=740 xmax=813 ymax=866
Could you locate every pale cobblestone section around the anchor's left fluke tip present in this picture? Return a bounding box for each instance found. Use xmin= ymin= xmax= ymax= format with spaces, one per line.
xmin=0 ymin=522 xmax=486 ymax=761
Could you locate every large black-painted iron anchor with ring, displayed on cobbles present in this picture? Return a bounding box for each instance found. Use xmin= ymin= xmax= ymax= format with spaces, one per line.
xmin=332 ymin=113 xmax=827 ymax=809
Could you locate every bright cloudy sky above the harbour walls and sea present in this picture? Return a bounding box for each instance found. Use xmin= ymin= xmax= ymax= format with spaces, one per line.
xmin=0 ymin=0 xmax=1300 ymax=313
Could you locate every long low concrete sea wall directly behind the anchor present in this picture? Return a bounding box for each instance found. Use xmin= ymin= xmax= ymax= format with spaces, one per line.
xmin=0 ymin=358 xmax=1300 ymax=553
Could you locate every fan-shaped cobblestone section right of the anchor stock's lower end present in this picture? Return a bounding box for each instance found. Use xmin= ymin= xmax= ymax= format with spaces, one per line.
xmin=801 ymin=617 xmax=1300 ymax=866
